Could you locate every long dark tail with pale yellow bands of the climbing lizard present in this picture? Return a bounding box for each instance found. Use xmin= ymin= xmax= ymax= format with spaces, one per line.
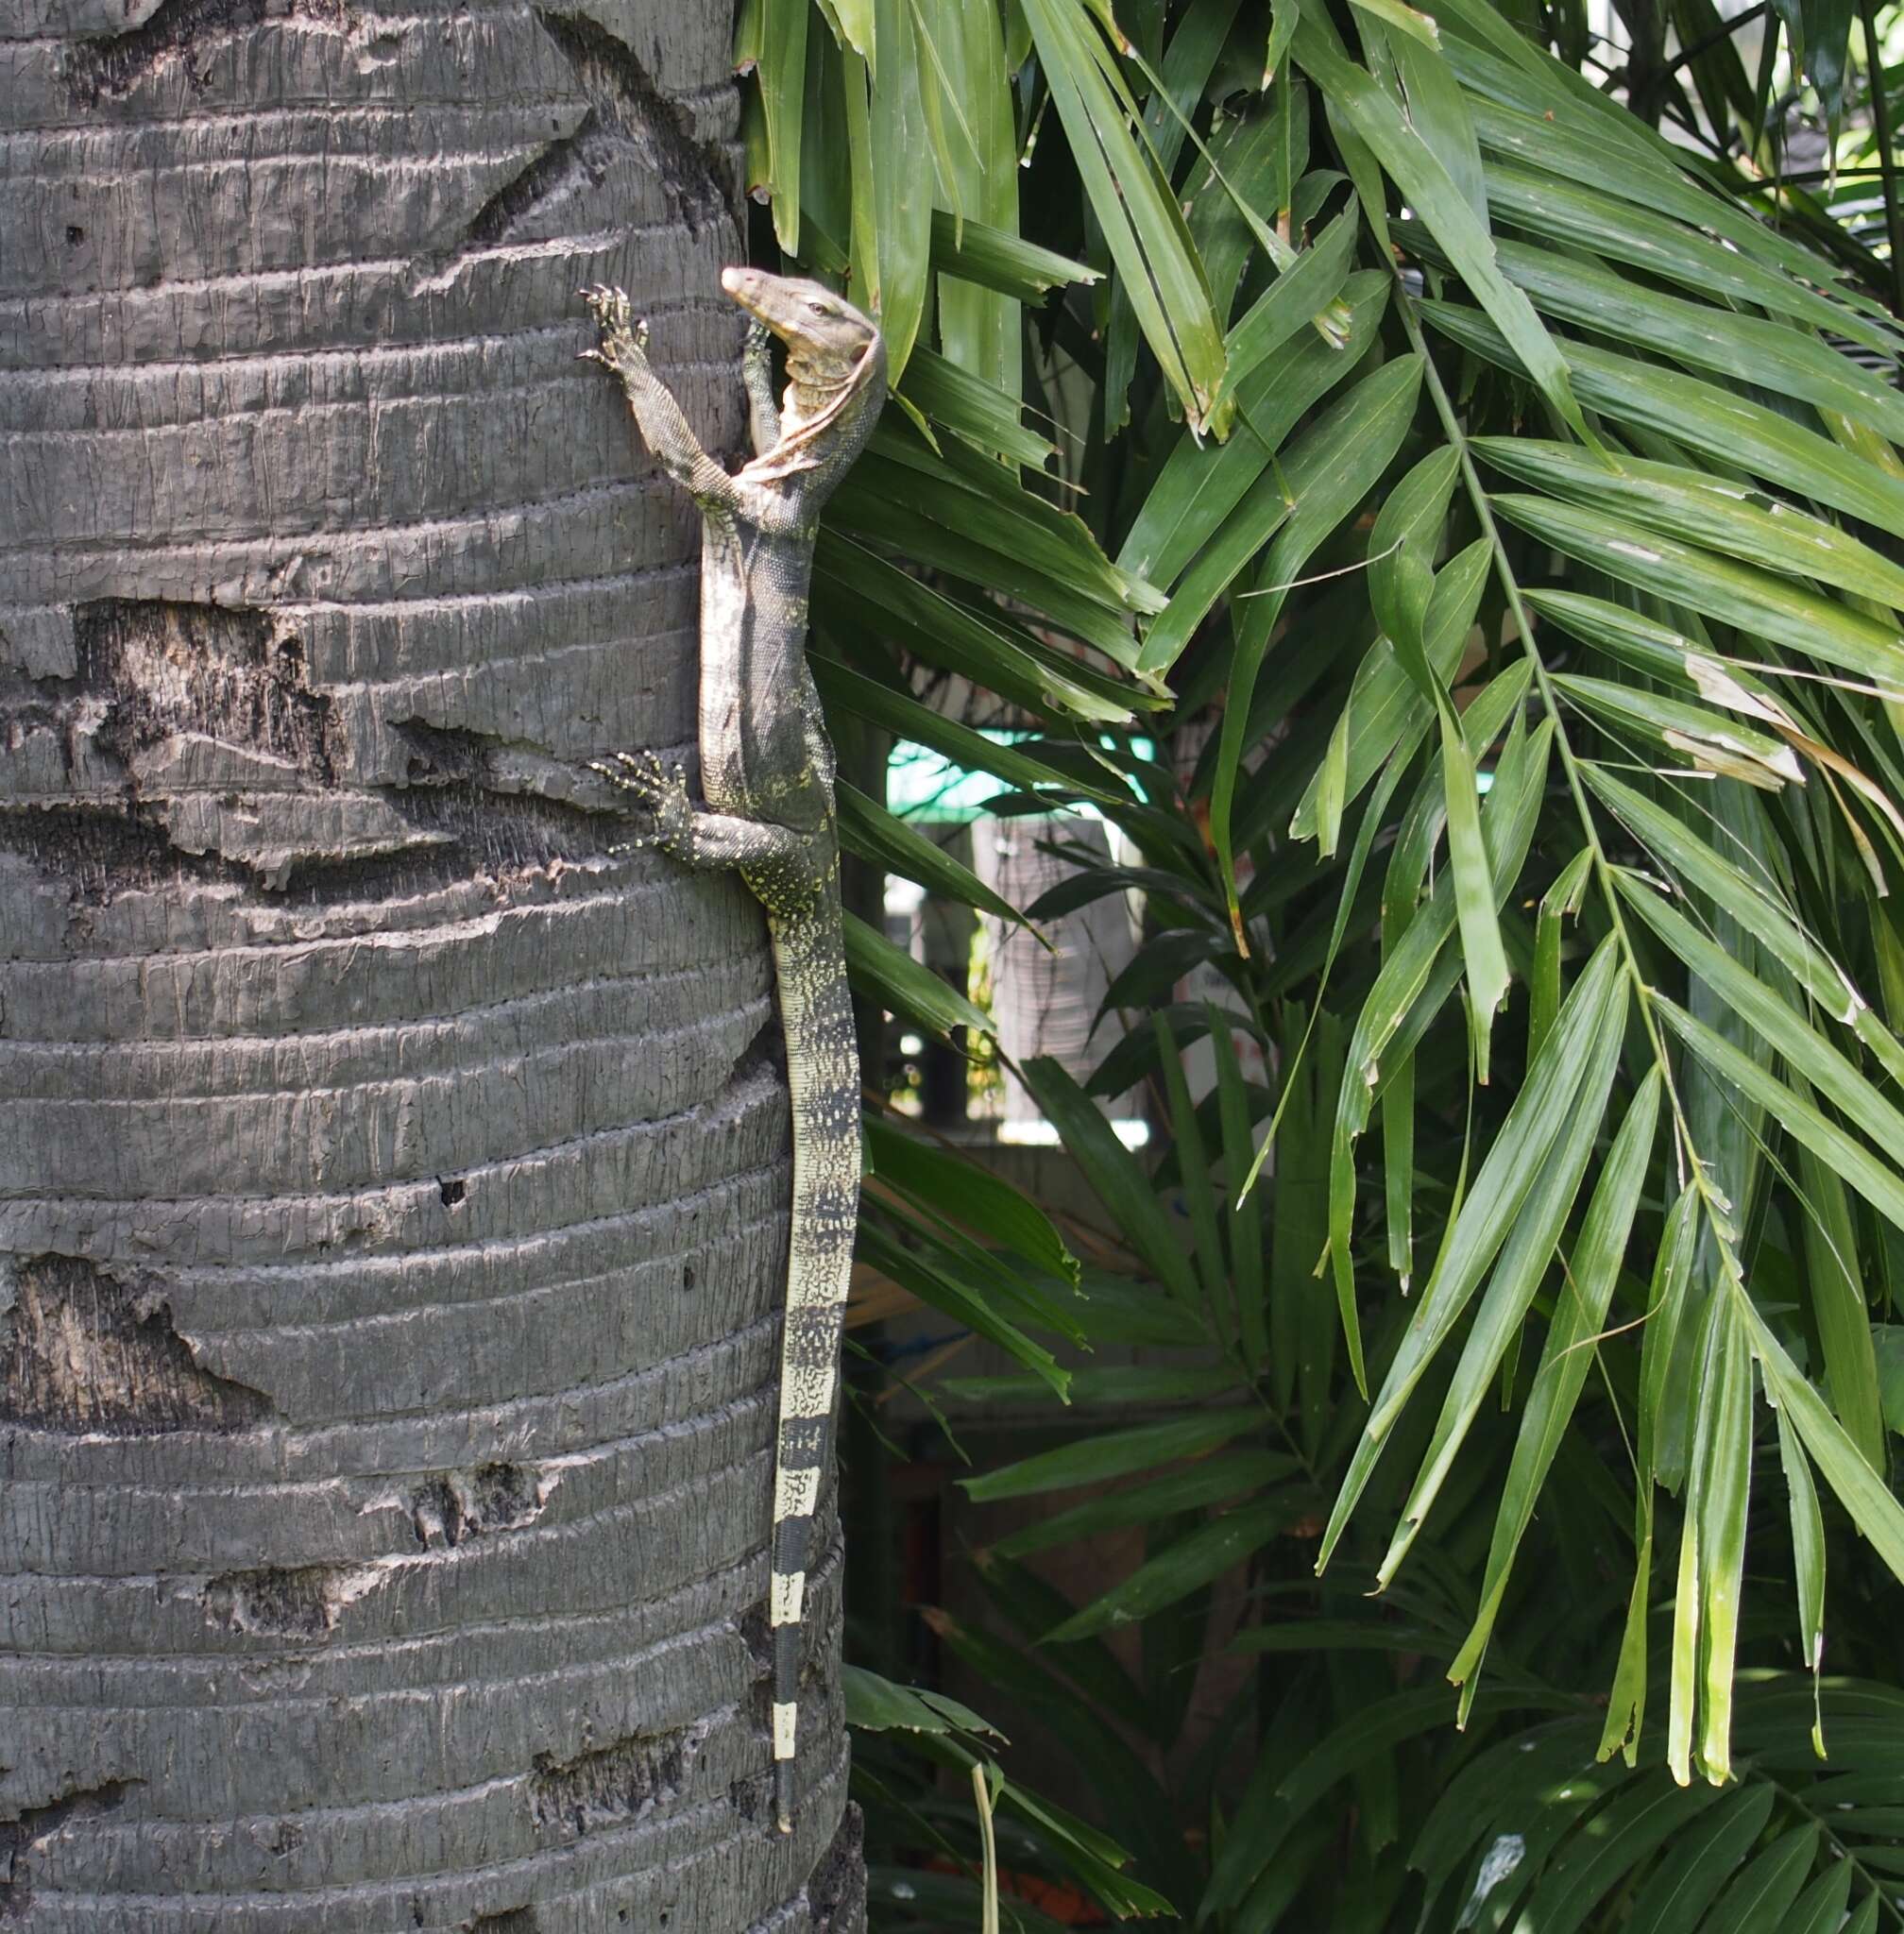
xmin=768 ymin=893 xmax=859 ymax=1834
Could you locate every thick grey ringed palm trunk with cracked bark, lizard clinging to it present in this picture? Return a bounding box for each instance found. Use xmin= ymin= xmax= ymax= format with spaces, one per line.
xmin=0 ymin=0 xmax=863 ymax=1934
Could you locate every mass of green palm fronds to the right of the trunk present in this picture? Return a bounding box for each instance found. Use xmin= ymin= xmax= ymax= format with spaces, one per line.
xmin=740 ymin=0 xmax=1904 ymax=1934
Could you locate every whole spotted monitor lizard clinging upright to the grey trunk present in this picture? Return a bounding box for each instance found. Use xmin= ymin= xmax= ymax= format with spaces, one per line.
xmin=586 ymin=269 xmax=886 ymax=1834
